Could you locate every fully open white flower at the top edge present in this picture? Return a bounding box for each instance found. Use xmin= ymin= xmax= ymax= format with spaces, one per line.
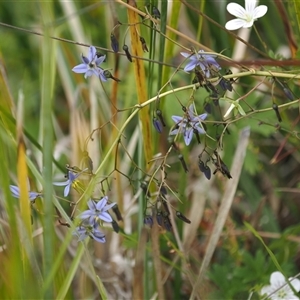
xmin=225 ymin=0 xmax=268 ymax=30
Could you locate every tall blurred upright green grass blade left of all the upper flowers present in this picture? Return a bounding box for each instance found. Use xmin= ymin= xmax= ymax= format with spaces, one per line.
xmin=40 ymin=2 xmax=55 ymax=299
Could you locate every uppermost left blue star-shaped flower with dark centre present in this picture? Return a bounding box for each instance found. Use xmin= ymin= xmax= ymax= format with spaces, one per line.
xmin=72 ymin=46 xmax=107 ymax=81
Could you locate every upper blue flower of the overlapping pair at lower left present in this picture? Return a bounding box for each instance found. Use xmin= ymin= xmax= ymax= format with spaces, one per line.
xmin=79 ymin=196 xmax=116 ymax=222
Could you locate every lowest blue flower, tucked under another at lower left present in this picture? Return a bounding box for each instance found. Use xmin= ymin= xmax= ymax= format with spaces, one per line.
xmin=73 ymin=220 xmax=106 ymax=243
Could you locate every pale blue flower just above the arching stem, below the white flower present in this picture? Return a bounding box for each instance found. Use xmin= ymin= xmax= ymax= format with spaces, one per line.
xmin=180 ymin=50 xmax=221 ymax=78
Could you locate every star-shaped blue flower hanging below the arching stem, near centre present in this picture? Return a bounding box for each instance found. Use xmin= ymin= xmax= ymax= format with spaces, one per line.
xmin=170 ymin=104 xmax=207 ymax=146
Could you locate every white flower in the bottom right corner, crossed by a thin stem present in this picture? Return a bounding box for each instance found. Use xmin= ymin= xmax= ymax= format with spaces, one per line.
xmin=260 ymin=272 xmax=300 ymax=300
